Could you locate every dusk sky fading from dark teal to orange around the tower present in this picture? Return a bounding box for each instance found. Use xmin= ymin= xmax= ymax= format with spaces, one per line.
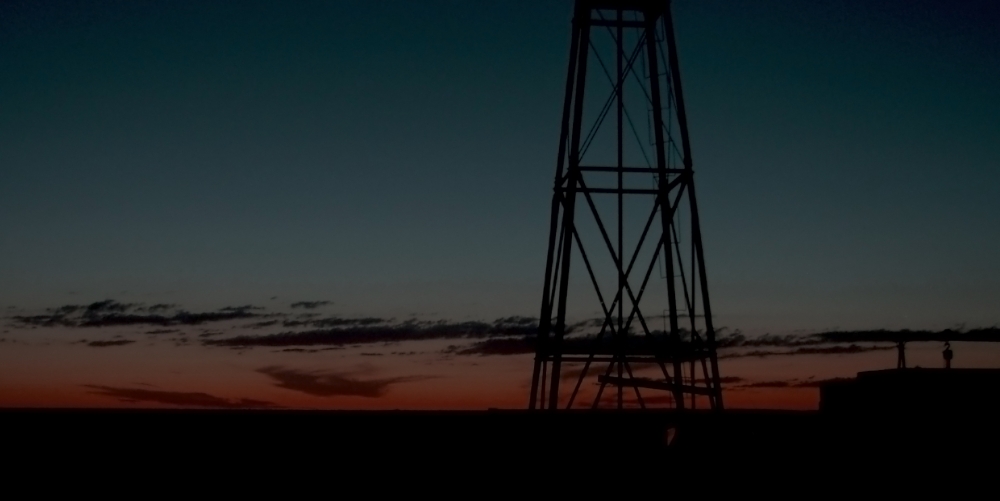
xmin=0 ymin=0 xmax=1000 ymax=406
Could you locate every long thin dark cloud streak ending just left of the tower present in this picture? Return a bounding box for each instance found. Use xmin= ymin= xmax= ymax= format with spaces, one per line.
xmin=204 ymin=317 xmax=537 ymax=347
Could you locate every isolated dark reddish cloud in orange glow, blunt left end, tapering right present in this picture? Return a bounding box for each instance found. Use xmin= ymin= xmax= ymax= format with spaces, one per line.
xmin=257 ymin=366 xmax=428 ymax=398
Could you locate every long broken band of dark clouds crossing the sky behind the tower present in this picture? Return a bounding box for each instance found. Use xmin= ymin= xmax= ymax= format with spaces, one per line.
xmin=15 ymin=299 xmax=1000 ymax=368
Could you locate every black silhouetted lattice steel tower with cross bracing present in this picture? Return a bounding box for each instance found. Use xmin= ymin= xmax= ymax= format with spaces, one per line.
xmin=529 ymin=0 xmax=722 ymax=410
